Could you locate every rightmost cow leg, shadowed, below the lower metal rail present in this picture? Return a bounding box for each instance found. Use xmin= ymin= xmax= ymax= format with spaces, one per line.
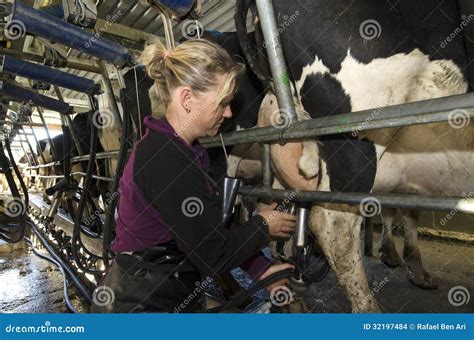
xmin=403 ymin=210 xmax=438 ymax=289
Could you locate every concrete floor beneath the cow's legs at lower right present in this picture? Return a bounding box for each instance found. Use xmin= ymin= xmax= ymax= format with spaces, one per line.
xmin=306 ymin=233 xmax=474 ymax=313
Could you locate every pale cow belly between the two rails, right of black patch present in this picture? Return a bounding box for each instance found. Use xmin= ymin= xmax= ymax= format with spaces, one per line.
xmin=373 ymin=124 xmax=474 ymax=196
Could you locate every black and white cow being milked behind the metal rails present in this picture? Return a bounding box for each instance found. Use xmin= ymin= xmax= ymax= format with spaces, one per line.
xmin=237 ymin=0 xmax=474 ymax=312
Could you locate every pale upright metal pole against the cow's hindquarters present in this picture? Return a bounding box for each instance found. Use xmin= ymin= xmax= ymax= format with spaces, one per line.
xmin=256 ymin=0 xmax=296 ymax=124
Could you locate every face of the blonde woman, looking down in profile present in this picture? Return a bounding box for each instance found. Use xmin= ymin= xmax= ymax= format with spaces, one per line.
xmin=192 ymin=75 xmax=232 ymax=137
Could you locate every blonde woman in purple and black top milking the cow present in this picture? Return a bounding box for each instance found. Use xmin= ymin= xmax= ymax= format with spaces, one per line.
xmin=91 ymin=40 xmax=295 ymax=312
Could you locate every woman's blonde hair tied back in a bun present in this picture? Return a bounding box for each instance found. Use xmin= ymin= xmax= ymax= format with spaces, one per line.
xmin=140 ymin=39 xmax=244 ymax=116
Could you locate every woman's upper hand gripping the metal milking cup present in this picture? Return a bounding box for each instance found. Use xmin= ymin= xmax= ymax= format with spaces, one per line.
xmin=259 ymin=203 xmax=296 ymax=240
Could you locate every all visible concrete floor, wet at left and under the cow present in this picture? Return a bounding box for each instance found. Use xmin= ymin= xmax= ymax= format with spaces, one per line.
xmin=0 ymin=233 xmax=474 ymax=313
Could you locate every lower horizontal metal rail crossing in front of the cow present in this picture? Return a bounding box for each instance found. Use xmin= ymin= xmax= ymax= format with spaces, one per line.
xmin=239 ymin=186 xmax=474 ymax=214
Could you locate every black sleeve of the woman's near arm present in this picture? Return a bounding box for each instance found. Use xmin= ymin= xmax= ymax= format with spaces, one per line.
xmin=134 ymin=133 xmax=269 ymax=275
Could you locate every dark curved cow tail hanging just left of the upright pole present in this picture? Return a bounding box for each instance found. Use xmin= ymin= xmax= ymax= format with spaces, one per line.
xmin=235 ymin=0 xmax=272 ymax=89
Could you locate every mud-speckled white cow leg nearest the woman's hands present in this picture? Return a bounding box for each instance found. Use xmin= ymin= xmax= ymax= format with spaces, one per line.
xmin=309 ymin=205 xmax=380 ymax=313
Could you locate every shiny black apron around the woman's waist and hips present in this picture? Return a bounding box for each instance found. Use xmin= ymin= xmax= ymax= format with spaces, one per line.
xmin=90 ymin=241 xmax=204 ymax=313
